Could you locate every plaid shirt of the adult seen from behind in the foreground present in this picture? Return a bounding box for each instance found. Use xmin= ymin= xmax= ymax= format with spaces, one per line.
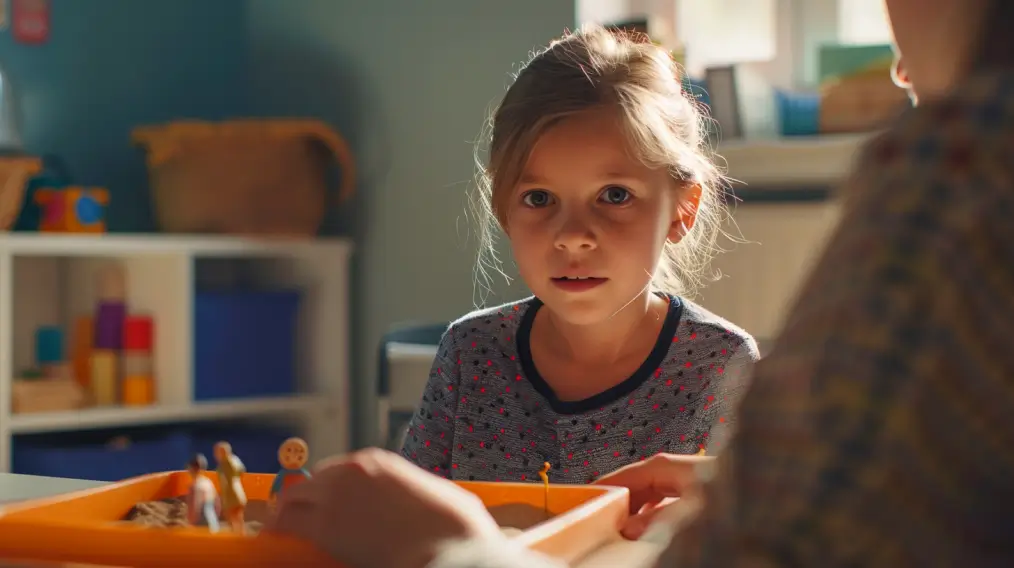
xmin=434 ymin=75 xmax=1014 ymax=568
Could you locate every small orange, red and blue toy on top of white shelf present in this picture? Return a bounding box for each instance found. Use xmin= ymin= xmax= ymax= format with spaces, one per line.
xmin=34 ymin=186 xmax=110 ymax=233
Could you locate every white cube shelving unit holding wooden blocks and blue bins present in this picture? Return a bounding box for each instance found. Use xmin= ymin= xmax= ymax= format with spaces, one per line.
xmin=0 ymin=233 xmax=352 ymax=472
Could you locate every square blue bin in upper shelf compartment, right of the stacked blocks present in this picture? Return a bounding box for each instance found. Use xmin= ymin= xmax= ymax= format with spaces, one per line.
xmin=194 ymin=291 xmax=300 ymax=401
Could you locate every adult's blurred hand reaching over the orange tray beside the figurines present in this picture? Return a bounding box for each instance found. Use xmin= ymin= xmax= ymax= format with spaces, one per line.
xmin=264 ymin=448 xmax=507 ymax=568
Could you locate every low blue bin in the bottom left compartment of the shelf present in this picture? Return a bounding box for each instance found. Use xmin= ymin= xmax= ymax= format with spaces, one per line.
xmin=11 ymin=429 xmax=192 ymax=482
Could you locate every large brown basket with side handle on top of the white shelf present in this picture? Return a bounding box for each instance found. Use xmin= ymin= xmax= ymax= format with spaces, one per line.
xmin=133 ymin=120 xmax=355 ymax=236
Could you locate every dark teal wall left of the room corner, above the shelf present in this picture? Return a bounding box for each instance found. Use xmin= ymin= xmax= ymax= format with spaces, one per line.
xmin=0 ymin=0 xmax=246 ymax=231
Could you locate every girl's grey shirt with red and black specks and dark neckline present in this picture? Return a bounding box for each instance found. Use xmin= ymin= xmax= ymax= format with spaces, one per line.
xmin=402 ymin=297 xmax=757 ymax=483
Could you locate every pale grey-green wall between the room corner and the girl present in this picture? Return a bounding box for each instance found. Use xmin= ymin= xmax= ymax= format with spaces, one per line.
xmin=247 ymin=0 xmax=575 ymax=443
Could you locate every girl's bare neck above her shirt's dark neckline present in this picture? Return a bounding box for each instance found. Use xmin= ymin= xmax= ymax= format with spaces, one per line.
xmin=540 ymin=291 xmax=668 ymax=364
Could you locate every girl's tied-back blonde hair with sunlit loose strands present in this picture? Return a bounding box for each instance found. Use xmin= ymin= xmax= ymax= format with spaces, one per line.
xmin=472 ymin=26 xmax=726 ymax=303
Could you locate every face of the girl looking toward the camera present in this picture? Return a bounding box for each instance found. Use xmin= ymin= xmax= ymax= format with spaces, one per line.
xmin=507 ymin=112 xmax=693 ymax=325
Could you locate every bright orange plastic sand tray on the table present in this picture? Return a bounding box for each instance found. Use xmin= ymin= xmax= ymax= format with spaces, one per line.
xmin=0 ymin=472 xmax=630 ymax=568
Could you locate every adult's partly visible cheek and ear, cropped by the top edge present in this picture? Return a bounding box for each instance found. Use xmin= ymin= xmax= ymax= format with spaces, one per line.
xmin=884 ymin=0 xmax=989 ymax=100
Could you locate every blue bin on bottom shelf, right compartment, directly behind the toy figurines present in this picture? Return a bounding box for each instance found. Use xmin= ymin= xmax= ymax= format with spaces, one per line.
xmin=193 ymin=427 xmax=294 ymax=474
